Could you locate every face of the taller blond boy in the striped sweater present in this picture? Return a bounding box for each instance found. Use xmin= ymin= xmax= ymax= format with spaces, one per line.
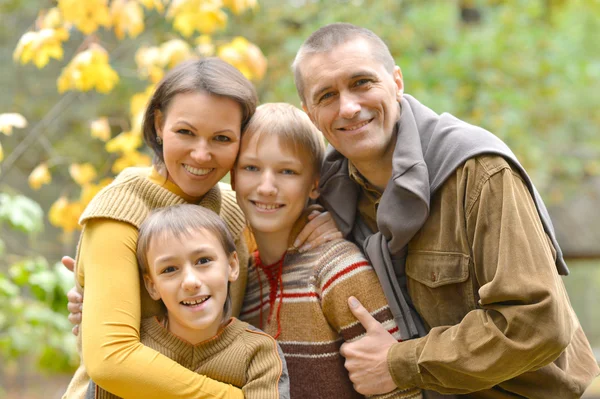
xmin=235 ymin=135 xmax=318 ymax=241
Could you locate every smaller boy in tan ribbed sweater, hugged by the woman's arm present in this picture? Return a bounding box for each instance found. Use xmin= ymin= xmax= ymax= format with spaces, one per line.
xmin=88 ymin=204 xmax=289 ymax=399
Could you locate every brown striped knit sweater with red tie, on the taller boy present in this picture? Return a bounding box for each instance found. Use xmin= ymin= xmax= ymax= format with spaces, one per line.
xmin=240 ymin=239 xmax=421 ymax=399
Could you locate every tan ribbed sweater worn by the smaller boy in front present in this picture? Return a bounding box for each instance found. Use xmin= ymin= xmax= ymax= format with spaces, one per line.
xmin=87 ymin=317 xmax=290 ymax=399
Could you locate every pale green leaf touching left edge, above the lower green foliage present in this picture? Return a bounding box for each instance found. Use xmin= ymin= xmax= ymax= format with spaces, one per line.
xmin=0 ymin=194 xmax=44 ymax=233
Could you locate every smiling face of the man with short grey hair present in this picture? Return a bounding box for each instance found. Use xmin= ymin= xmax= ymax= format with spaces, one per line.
xmin=300 ymin=38 xmax=403 ymax=164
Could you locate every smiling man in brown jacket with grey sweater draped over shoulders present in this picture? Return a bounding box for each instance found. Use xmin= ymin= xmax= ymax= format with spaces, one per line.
xmin=293 ymin=24 xmax=599 ymax=398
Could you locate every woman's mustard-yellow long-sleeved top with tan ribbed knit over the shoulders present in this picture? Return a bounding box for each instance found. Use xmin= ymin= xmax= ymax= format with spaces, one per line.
xmin=63 ymin=168 xmax=248 ymax=399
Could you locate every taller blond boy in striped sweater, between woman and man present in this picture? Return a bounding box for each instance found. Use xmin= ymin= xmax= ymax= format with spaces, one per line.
xmin=234 ymin=104 xmax=421 ymax=399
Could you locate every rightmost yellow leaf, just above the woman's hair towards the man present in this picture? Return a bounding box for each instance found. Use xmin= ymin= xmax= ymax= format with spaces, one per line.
xmin=217 ymin=36 xmax=267 ymax=80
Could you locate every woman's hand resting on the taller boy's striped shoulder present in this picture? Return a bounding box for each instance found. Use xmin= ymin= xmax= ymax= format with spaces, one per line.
xmin=294 ymin=205 xmax=342 ymax=252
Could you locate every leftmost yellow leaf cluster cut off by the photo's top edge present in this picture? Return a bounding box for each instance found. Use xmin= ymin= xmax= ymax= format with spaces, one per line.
xmin=58 ymin=0 xmax=111 ymax=35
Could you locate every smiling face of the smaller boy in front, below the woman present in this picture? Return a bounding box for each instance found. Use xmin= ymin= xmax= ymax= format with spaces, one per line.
xmin=144 ymin=229 xmax=239 ymax=344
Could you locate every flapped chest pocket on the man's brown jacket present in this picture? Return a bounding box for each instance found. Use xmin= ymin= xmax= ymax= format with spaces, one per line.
xmin=406 ymin=250 xmax=476 ymax=327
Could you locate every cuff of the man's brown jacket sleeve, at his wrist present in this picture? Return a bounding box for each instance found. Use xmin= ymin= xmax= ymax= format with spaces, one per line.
xmin=387 ymin=338 xmax=422 ymax=390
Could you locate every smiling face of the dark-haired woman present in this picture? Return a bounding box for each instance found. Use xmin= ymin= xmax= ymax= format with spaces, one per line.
xmin=155 ymin=92 xmax=242 ymax=199
